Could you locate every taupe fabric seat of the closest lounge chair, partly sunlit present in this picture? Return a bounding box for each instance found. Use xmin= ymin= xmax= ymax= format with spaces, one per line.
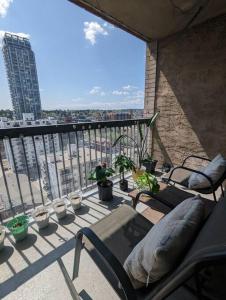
xmin=84 ymin=204 xmax=153 ymax=299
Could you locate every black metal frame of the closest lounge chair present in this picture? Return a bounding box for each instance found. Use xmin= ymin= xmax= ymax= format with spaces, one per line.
xmin=72 ymin=228 xmax=226 ymax=300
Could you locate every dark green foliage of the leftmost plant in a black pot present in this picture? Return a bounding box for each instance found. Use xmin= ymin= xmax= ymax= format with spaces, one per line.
xmin=88 ymin=163 xmax=115 ymax=186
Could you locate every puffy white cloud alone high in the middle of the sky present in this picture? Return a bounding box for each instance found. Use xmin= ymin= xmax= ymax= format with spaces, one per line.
xmin=83 ymin=22 xmax=108 ymax=45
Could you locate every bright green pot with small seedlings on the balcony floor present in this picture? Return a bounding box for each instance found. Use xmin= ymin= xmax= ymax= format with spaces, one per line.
xmin=6 ymin=215 xmax=29 ymax=242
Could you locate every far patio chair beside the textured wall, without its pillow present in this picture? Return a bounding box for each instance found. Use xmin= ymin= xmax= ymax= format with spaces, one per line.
xmin=164 ymin=155 xmax=226 ymax=201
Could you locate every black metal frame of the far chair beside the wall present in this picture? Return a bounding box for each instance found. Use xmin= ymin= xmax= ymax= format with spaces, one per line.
xmin=167 ymin=155 xmax=226 ymax=202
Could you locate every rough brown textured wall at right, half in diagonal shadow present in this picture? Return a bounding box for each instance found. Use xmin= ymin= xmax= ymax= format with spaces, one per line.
xmin=145 ymin=16 xmax=226 ymax=165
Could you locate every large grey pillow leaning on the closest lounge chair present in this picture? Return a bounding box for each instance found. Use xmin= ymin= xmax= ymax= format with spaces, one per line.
xmin=124 ymin=196 xmax=204 ymax=289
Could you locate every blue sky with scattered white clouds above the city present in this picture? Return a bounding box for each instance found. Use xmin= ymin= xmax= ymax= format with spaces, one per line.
xmin=0 ymin=0 xmax=145 ymax=109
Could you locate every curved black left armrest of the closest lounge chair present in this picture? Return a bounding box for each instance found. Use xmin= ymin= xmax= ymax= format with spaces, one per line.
xmin=76 ymin=227 xmax=136 ymax=300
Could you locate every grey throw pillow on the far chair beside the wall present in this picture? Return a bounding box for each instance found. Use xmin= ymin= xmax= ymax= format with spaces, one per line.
xmin=188 ymin=154 xmax=226 ymax=190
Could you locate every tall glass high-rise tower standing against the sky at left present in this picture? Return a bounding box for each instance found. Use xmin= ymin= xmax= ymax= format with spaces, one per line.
xmin=2 ymin=33 xmax=41 ymax=120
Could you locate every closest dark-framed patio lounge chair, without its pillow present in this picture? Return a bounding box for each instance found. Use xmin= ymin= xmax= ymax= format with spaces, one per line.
xmin=73 ymin=199 xmax=226 ymax=300
